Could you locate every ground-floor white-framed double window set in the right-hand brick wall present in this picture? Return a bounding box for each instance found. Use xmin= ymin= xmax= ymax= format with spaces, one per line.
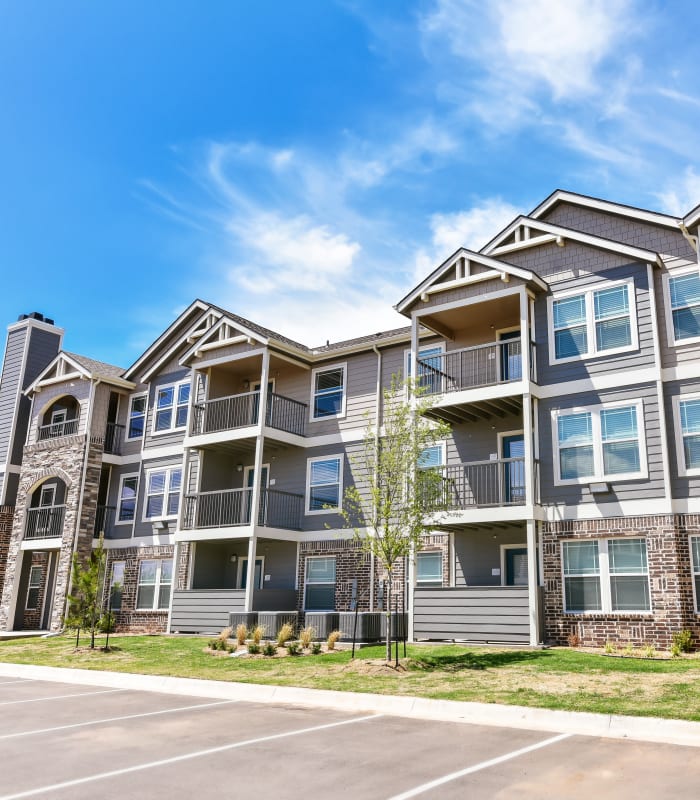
xmin=562 ymin=538 xmax=651 ymax=614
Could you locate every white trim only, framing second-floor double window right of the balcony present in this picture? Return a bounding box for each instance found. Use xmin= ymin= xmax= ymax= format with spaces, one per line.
xmin=552 ymin=400 xmax=649 ymax=486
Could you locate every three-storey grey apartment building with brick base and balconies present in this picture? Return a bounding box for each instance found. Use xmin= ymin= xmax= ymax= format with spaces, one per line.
xmin=0 ymin=191 xmax=700 ymax=646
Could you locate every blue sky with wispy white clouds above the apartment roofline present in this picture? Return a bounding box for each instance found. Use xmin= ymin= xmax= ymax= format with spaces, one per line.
xmin=0 ymin=0 xmax=700 ymax=366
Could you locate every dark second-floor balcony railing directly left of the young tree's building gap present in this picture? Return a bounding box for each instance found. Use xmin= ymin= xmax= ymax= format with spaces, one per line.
xmin=182 ymin=488 xmax=304 ymax=530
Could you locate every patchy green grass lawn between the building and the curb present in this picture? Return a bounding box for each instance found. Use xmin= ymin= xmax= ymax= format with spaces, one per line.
xmin=0 ymin=636 xmax=700 ymax=721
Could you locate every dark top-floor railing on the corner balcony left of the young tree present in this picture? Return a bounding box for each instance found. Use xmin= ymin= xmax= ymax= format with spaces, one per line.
xmin=191 ymin=392 xmax=307 ymax=436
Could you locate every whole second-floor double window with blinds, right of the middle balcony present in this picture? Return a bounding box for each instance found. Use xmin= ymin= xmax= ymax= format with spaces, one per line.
xmin=552 ymin=400 xmax=647 ymax=484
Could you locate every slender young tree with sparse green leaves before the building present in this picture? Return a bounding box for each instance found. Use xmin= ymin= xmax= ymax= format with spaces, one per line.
xmin=341 ymin=375 xmax=450 ymax=661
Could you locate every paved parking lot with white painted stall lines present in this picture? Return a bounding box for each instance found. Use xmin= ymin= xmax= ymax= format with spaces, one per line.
xmin=0 ymin=677 xmax=700 ymax=800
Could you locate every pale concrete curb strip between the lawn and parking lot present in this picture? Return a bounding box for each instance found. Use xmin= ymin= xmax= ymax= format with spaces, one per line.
xmin=0 ymin=663 xmax=700 ymax=747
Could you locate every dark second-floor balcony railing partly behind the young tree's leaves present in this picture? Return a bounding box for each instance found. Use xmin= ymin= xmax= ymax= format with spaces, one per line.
xmin=418 ymin=458 xmax=538 ymax=511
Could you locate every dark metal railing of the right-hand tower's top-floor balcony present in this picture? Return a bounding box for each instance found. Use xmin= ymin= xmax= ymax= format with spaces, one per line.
xmin=418 ymin=339 xmax=523 ymax=394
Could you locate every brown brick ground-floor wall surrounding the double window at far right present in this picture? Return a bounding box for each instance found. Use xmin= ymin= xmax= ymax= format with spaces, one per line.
xmin=542 ymin=515 xmax=700 ymax=648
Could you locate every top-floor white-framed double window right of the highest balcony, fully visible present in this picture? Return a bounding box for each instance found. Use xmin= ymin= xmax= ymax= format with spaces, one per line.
xmin=548 ymin=279 xmax=638 ymax=364
